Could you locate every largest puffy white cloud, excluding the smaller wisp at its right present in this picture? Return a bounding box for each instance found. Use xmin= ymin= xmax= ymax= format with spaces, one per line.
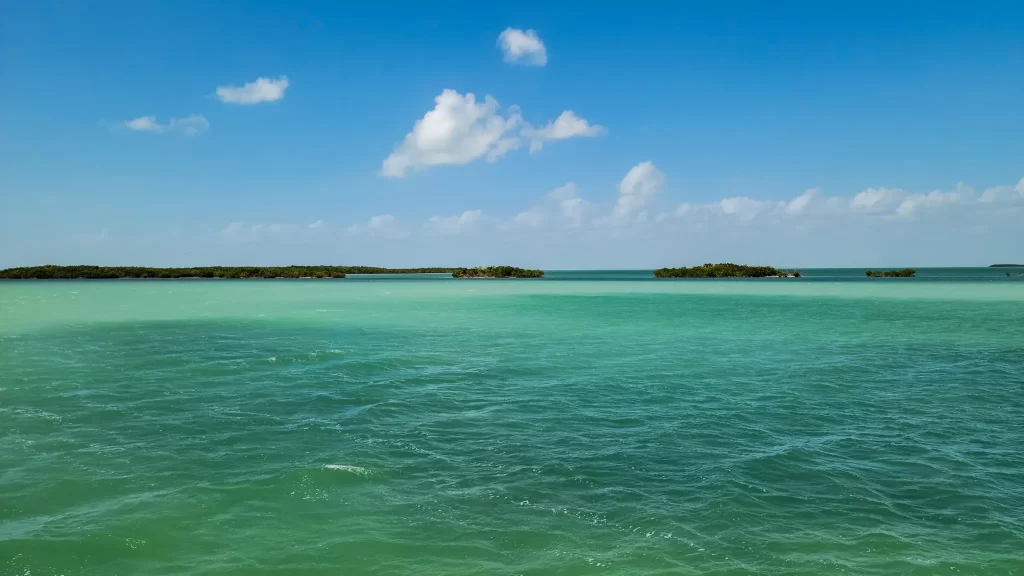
xmin=381 ymin=90 xmax=521 ymax=178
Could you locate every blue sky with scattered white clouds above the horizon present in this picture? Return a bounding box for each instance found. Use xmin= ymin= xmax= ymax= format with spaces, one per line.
xmin=0 ymin=1 xmax=1024 ymax=269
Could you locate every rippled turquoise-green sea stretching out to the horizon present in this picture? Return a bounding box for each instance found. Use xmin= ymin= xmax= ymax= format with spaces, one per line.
xmin=0 ymin=269 xmax=1024 ymax=576
